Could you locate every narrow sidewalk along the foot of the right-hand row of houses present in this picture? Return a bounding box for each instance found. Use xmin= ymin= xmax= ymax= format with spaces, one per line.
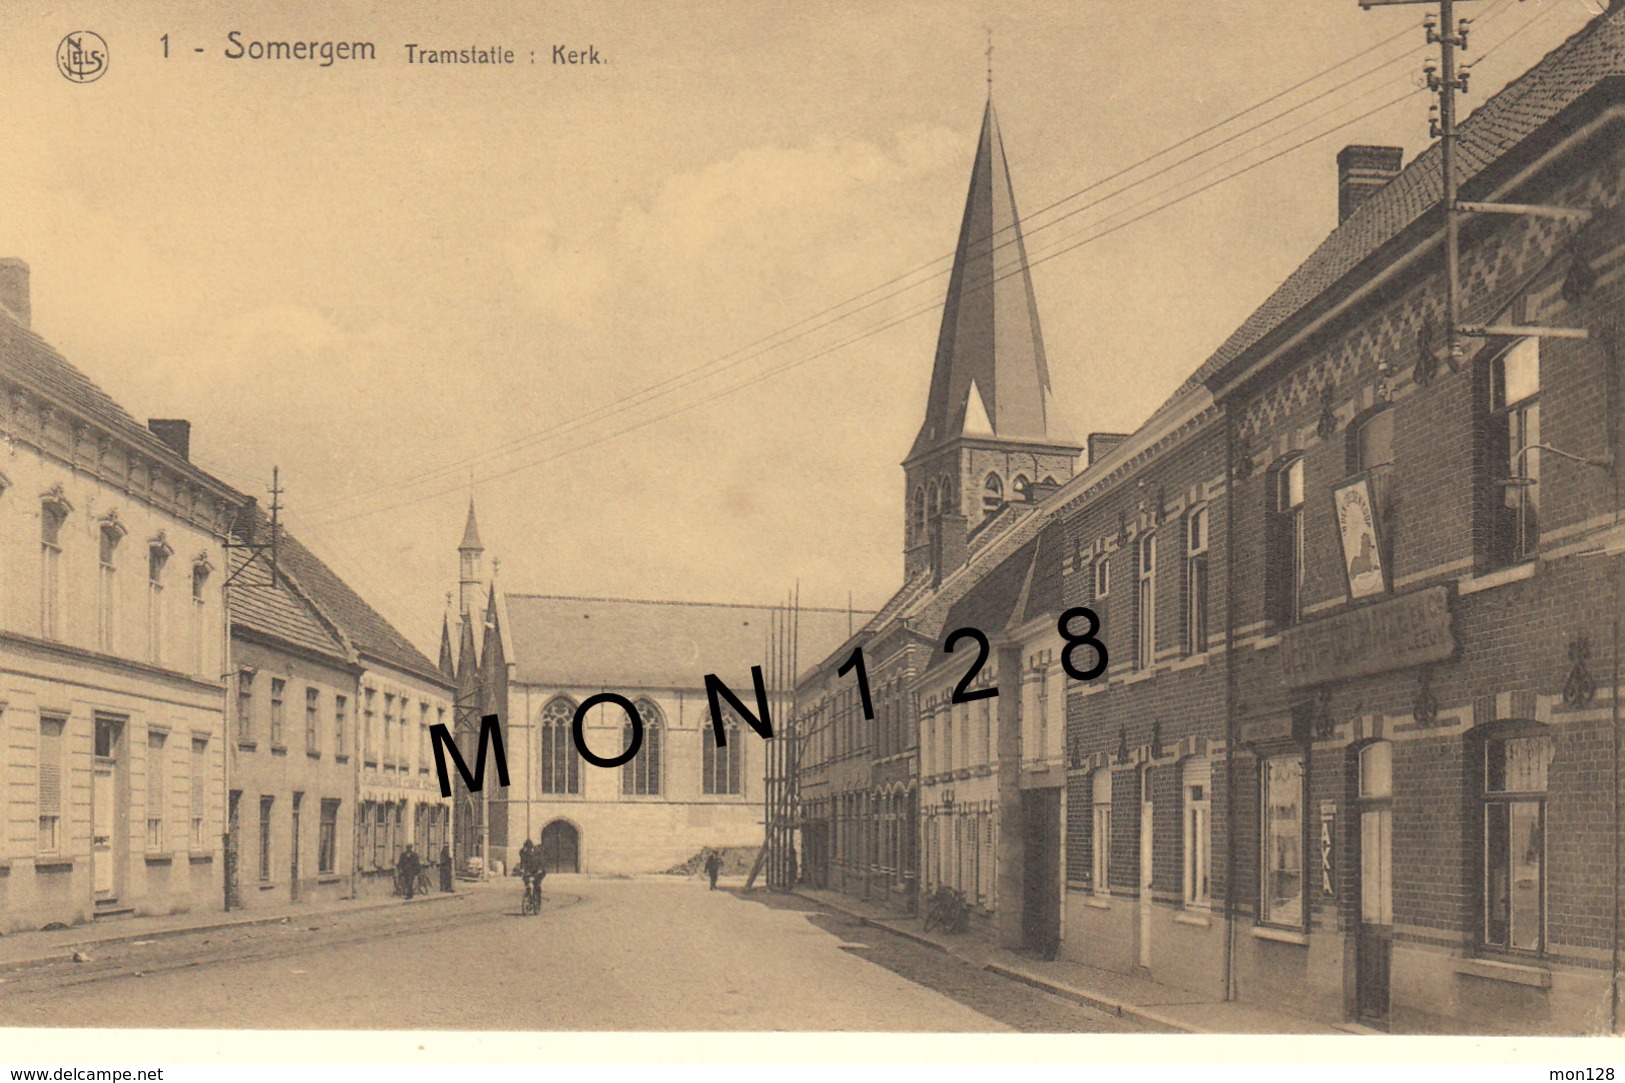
xmin=796 ymin=888 xmax=1349 ymax=1034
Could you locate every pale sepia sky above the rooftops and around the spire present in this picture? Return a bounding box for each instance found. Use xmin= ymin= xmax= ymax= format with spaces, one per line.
xmin=0 ymin=0 xmax=1602 ymax=657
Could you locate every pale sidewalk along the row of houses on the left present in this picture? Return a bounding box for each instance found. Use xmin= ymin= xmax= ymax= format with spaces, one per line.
xmin=0 ymin=881 xmax=481 ymax=972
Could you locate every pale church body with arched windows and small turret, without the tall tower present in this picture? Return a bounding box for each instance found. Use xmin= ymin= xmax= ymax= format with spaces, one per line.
xmin=440 ymin=501 xmax=871 ymax=875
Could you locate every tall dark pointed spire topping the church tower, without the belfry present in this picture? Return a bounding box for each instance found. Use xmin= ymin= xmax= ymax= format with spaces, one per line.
xmin=908 ymin=95 xmax=1069 ymax=459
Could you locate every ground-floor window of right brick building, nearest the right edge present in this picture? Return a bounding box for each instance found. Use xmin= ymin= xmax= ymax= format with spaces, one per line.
xmin=1484 ymin=733 xmax=1554 ymax=955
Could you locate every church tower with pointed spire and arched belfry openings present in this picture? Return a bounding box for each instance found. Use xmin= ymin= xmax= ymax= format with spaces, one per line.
xmin=902 ymin=97 xmax=1082 ymax=579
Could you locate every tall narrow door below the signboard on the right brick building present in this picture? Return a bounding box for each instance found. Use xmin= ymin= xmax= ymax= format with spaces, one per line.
xmin=1355 ymin=742 xmax=1394 ymax=1029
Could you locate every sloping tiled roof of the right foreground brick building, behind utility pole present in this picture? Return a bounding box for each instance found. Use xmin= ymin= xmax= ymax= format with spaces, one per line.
xmin=1175 ymin=3 xmax=1625 ymax=397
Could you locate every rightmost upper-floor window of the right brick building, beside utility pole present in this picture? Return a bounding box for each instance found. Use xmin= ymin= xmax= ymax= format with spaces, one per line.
xmin=1485 ymin=338 xmax=1541 ymax=564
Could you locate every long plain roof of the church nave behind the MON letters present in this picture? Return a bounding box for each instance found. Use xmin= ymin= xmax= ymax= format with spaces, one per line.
xmin=507 ymin=594 xmax=869 ymax=686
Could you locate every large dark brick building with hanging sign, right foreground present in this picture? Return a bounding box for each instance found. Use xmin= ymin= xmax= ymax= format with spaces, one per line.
xmin=1055 ymin=5 xmax=1625 ymax=1033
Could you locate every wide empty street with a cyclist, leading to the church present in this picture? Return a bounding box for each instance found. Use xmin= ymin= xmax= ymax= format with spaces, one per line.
xmin=0 ymin=875 xmax=1133 ymax=1033
